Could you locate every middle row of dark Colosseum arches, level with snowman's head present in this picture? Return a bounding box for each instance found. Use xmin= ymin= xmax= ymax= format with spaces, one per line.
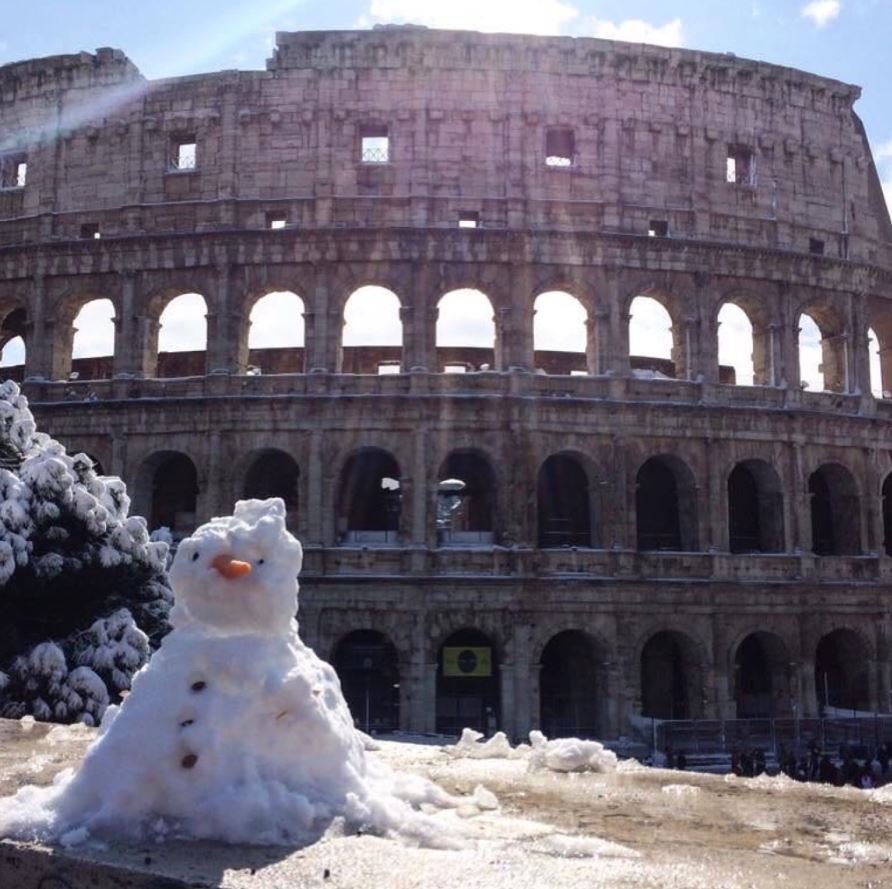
xmin=135 ymin=447 xmax=892 ymax=556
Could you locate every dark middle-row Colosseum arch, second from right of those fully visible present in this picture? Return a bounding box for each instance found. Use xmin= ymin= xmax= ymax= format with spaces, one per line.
xmin=728 ymin=460 xmax=784 ymax=553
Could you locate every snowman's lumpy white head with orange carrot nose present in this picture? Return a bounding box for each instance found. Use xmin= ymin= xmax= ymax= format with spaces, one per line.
xmin=170 ymin=497 xmax=303 ymax=635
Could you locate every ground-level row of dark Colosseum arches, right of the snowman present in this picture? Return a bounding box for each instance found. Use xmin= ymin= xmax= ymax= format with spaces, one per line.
xmin=331 ymin=628 xmax=873 ymax=737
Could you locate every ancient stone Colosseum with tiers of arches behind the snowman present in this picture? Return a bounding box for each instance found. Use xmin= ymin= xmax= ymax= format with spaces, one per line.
xmin=0 ymin=28 xmax=892 ymax=738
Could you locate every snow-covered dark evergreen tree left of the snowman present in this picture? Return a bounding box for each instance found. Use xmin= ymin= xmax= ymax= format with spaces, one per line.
xmin=0 ymin=381 xmax=171 ymax=724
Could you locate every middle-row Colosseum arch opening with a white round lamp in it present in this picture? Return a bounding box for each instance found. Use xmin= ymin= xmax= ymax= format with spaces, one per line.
xmin=437 ymin=450 xmax=496 ymax=546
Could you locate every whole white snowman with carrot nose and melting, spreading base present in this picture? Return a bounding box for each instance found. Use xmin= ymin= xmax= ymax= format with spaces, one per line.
xmin=0 ymin=498 xmax=497 ymax=847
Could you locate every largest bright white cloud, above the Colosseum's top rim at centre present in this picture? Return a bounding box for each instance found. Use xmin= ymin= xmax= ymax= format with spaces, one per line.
xmin=359 ymin=0 xmax=579 ymax=34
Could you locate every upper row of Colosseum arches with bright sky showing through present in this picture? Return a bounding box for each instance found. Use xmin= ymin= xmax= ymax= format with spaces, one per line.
xmin=0 ymin=285 xmax=892 ymax=397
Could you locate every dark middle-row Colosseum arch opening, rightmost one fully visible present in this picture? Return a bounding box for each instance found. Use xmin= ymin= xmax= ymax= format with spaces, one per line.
xmin=808 ymin=463 xmax=861 ymax=556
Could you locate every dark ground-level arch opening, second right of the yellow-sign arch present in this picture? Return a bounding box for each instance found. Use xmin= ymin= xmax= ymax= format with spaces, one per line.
xmin=641 ymin=630 xmax=705 ymax=719
